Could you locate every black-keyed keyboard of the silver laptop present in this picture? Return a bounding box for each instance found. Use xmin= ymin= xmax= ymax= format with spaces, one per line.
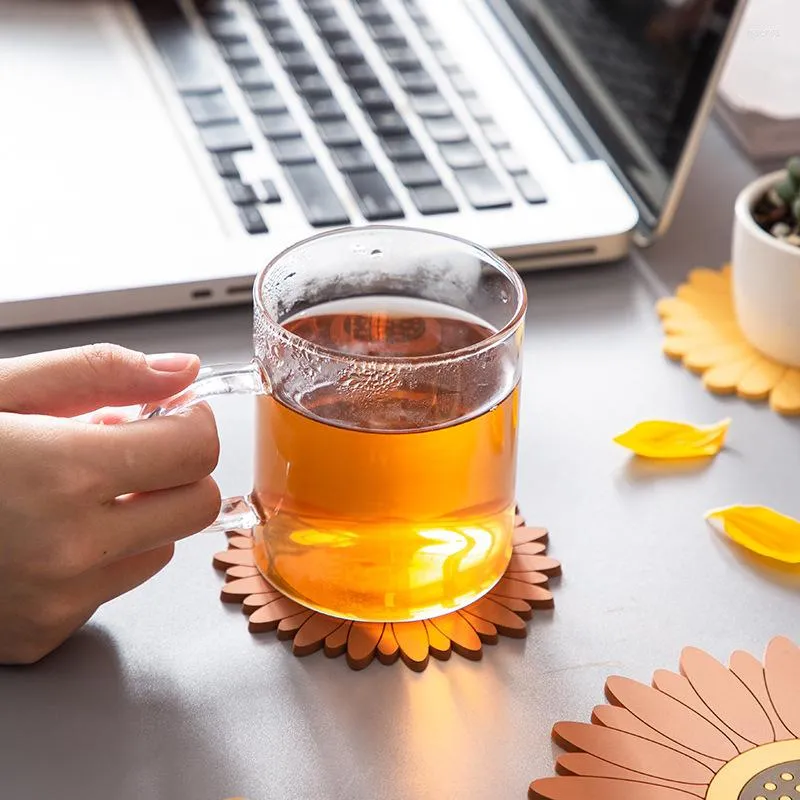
xmin=137 ymin=0 xmax=546 ymax=234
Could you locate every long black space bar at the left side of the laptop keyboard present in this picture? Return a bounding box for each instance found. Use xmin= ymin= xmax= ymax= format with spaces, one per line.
xmin=138 ymin=0 xmax=219 ymax=92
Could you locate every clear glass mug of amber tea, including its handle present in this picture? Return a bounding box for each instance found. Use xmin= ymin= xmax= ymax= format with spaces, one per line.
xmin=143 ymin=226 xmax=526 ymax=622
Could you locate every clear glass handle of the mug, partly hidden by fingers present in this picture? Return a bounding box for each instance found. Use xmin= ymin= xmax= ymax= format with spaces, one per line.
xmin=139 ymin=361 xmax=269 ymax=532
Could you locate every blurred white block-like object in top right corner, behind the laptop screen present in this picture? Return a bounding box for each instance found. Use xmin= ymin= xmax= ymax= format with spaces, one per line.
xmin=717 ymin=0 xmax=800 ymax=159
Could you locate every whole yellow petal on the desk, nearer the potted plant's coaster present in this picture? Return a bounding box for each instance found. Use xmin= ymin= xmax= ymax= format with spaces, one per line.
xmin=614 ymin=419 xmax=731 ymax=458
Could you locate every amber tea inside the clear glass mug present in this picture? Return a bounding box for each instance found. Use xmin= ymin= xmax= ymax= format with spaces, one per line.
xmin=252 ymin=297 xmax=518 ymax=621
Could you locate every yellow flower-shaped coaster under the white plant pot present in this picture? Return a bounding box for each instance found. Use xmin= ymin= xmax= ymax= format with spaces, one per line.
xmin=656 ymin=266 xmax=800 ymax=414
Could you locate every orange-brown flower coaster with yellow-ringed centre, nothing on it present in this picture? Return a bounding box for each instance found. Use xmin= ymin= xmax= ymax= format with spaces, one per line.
xmin=528 ymin=637 xmax=800 ymax=800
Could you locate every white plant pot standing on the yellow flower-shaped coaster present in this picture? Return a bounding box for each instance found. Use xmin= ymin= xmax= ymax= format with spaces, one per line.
xmin=732 ymin=171 xmax=800 ymax=367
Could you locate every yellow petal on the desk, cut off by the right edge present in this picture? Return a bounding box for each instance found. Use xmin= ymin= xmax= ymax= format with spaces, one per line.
xmin=706 ymin=506 xmax=800 ymax=564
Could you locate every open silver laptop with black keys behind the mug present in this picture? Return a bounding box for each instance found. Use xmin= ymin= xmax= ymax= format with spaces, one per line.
xmin=0 ymin=0 xmax=743 ymax=328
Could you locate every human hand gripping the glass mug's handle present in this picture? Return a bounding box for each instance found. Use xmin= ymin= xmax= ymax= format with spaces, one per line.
xmin=0 ymin=345 xmax=220 ymax=664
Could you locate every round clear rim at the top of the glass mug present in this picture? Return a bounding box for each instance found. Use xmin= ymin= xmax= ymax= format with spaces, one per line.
xmin=253 ymin=225 xmax=528 ymax=366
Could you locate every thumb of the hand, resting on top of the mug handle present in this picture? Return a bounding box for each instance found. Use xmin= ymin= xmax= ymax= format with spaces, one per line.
xmin=0 ymin=344 xmax=200 ymax=417
